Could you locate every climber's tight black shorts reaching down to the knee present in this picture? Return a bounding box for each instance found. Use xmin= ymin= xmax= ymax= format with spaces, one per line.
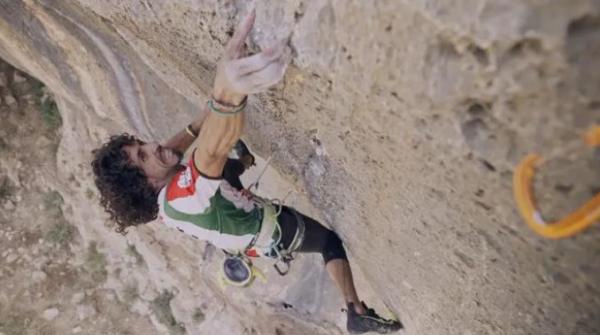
xmin=277 ymin=206 xmax=348 ymax=264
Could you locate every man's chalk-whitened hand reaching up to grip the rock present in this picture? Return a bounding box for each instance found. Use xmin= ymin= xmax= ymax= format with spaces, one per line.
xmin=213 ymin=10 xmax=291 ymax=105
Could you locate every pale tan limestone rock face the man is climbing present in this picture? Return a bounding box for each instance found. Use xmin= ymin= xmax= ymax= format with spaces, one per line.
xmin=0 ymin=0 xmax=600 ymax=334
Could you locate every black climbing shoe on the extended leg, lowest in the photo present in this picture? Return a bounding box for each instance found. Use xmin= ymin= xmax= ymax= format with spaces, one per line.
xmin=346 ymin=302 xmax=402 ymax=334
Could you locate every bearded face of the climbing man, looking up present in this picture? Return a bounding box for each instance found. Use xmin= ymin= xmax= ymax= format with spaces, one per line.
xmin=123 ymin=141 xmax=182 ymax=189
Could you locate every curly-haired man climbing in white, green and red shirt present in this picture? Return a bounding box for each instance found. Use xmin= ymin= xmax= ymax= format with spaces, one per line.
xmin=92 ymin=11 xmax=402 ymax=334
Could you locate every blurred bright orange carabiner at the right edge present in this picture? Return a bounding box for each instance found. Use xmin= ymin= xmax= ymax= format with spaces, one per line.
xmin=513 ymin=126 xmax=600 ymax=239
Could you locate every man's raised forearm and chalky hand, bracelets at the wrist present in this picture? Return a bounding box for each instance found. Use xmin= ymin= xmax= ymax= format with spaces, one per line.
xmin=194 ymin=11 xmax=289 ymax=178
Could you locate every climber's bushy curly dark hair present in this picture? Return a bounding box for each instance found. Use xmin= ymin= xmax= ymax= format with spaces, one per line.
xmin=92 ymin=133 xmax=158 ymax=235
